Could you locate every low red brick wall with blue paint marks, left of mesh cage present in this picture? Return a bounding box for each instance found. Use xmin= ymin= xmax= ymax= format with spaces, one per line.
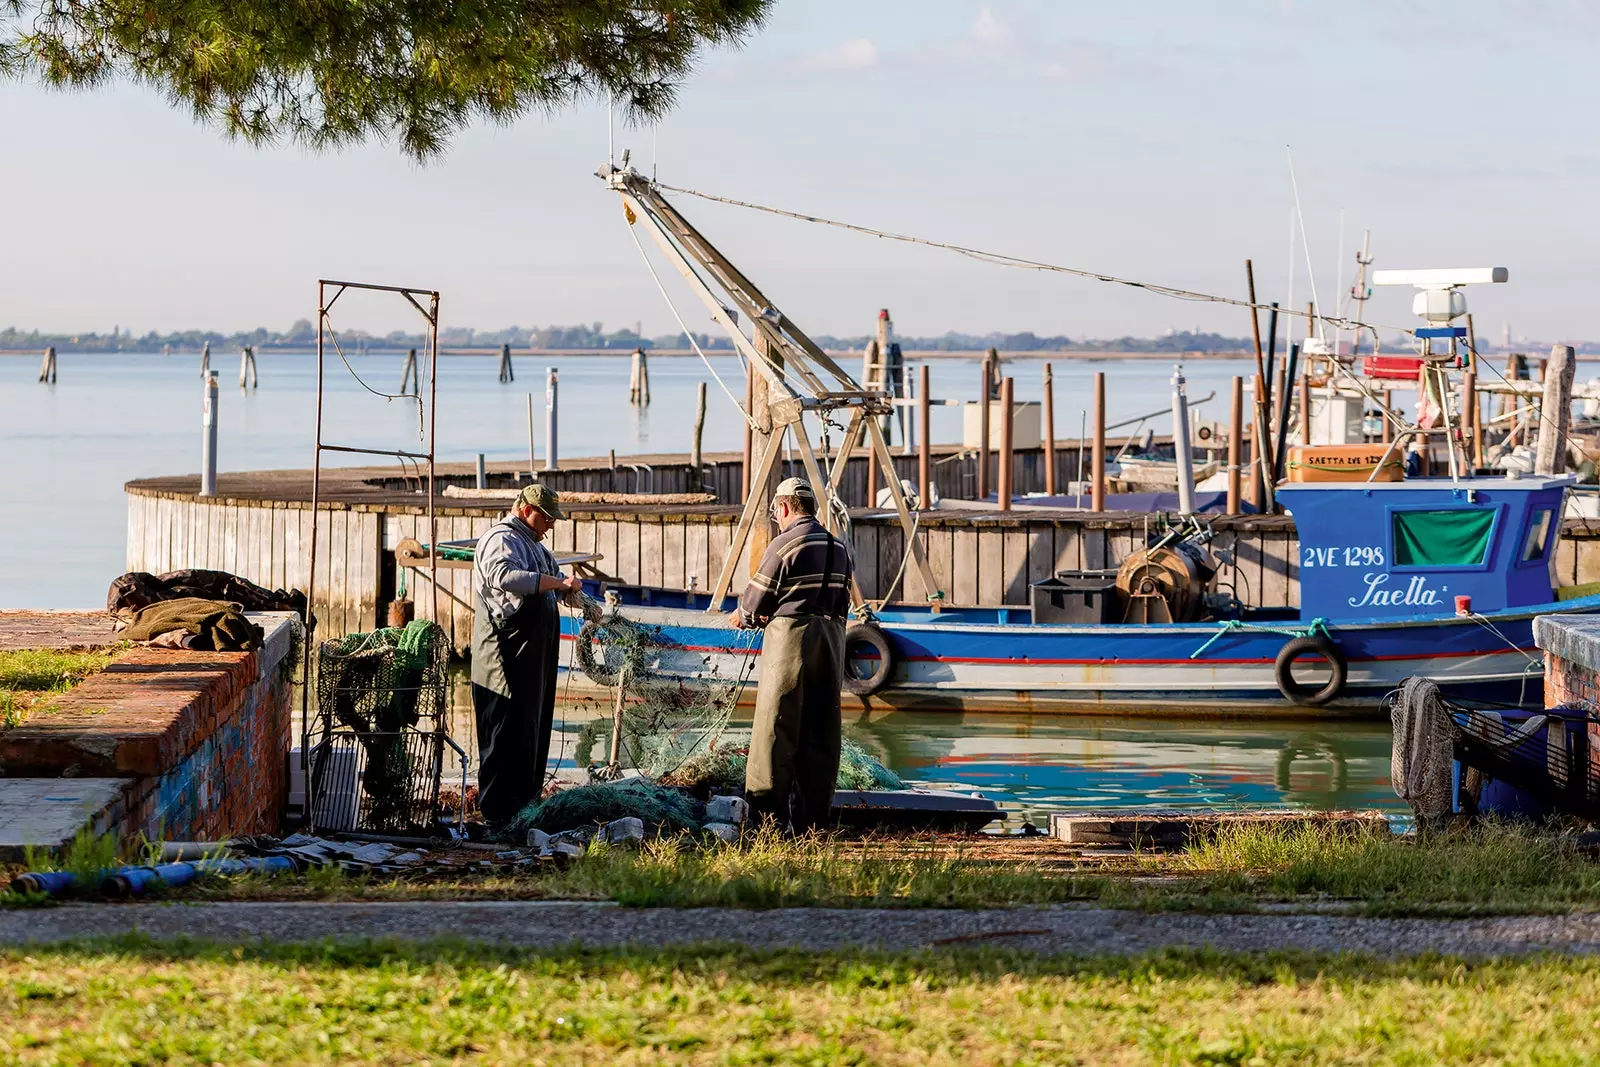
xmin=0 ymin=613 xmax=296 ymax=841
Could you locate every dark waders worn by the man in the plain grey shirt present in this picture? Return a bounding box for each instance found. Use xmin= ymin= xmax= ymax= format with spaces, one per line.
xmin=472 ymin=593 xmax=562 ymax=829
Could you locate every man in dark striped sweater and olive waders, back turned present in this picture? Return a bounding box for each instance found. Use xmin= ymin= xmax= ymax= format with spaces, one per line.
xmin=728 ymin=478 xmax=854 ymax=830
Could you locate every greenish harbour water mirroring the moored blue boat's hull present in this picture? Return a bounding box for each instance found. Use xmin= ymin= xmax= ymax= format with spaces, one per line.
xmin=446 ymin=669 xmax=1406 ymax=824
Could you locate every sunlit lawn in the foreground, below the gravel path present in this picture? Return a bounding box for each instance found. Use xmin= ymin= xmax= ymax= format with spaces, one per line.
xmin=0 ymin=941 xmax=1600 ymax=1065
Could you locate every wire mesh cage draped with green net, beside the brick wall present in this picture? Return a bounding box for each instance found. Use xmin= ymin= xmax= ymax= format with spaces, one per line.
xmin=310 ymin=619 xmax=450 ymax=833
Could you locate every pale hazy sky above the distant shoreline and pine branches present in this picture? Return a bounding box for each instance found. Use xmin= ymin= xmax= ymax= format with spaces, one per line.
xmin=0 ymin=0 xmax=1600 ymax=341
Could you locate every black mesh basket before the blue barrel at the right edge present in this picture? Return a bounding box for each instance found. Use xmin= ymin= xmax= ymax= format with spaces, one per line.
xmin=1450 ymin=705 xmax=1600 ymax=817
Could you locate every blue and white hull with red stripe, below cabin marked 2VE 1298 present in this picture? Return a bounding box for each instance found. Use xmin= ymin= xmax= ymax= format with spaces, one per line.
xmin=563 ymin=593 xmax=1600 ymax=715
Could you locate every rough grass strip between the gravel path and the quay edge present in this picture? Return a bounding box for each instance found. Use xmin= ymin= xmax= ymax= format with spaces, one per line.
xmin=12 ymin=824 xmax=1600 ymax=917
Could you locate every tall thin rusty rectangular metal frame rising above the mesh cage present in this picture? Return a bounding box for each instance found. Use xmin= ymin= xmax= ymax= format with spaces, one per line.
xmin=301 ymin=278 xmax=438 ymax=824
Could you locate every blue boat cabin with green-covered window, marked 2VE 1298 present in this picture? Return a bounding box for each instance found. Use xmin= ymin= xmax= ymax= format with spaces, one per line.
xmin=1277 ymin=475 xmax=1576 ymax=619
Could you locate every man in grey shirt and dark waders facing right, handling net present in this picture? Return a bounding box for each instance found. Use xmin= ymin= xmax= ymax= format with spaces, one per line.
xmin=472 ymin=485 xmax=582 ymax=835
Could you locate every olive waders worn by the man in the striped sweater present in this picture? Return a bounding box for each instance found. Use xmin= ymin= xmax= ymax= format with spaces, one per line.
xmin=744 ymin=616 xmax=845 ymax=830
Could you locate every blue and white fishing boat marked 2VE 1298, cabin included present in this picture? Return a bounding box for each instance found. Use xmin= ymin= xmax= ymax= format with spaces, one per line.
xmin=563 ymin=475 xmax=1600 ymax=715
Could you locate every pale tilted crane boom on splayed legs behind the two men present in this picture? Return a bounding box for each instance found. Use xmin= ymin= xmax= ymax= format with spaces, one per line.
xmin=598 ymin=158 xmax=942 ymax=611
